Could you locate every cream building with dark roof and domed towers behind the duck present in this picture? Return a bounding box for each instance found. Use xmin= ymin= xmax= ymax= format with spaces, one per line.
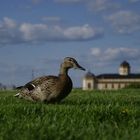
xmin=83 ymin=61 xmax=140 ymax=90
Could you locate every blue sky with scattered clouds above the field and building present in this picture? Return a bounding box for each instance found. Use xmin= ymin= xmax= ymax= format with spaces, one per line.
xmin=0 ymin=0 xmax=140 ymax=87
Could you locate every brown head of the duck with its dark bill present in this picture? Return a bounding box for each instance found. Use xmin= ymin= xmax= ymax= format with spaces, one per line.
xmin=62 ymin=57 xmax=85 ymax=71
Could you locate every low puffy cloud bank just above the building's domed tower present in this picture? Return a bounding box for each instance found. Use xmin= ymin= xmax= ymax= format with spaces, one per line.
xmin=91 ymin=47 xmax=140 ymax=62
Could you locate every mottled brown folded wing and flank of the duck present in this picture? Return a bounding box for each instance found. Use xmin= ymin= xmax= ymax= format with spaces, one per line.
xmin=16 ymin=76 xmax=59 ymax=101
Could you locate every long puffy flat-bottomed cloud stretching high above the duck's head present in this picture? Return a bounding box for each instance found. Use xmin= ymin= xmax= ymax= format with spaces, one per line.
xmin=20 ymin=23 xmax=102 ymax=42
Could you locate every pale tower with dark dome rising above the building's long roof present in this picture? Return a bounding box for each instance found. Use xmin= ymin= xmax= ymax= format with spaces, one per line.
xmin=119 ymin=61 xmax=131 ymax=76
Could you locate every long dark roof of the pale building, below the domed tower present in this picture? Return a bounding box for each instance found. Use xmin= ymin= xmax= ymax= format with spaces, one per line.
xmin=96 ymin=74 xmax=140 ymax=79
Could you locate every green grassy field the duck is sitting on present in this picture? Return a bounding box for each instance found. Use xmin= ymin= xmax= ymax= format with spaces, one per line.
xmin=0 ymin=89 xmax=140 ymax=140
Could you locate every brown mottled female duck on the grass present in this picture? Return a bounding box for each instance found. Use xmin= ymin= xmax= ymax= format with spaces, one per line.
xmin=15 ymin=57 xmax=85 ymax=103
